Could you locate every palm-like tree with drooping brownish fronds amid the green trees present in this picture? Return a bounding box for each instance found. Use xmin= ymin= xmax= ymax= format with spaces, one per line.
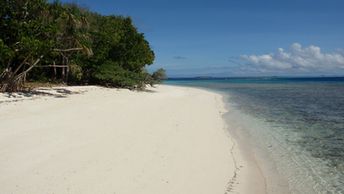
xmin=45 ymin=2 xmax=93 ymax=82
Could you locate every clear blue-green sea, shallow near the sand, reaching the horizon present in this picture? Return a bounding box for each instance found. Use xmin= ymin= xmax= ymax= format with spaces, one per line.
xmin=166 ymin=77 xmax=344 ymax=194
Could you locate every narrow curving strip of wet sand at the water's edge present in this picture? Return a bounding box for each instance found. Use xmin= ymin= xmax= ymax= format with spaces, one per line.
xmin=167 ymin=84 xmax=291 ymax=194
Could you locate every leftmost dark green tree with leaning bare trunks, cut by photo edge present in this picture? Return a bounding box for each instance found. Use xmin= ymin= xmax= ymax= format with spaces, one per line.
xmin=0 ymin=0 xmax=51 ymax=92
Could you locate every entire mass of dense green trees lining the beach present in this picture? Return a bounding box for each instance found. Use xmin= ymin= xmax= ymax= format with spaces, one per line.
xmin=0 ymin=0 xmax=162 ymax=92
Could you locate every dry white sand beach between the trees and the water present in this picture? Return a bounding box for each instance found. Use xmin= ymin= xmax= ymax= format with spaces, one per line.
xmin=0 ymin=85 xmax=264 ymax=194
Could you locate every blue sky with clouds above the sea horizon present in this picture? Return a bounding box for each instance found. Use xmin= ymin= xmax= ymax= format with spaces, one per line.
xmin=62 ymin=0 xmax=344 ymax=77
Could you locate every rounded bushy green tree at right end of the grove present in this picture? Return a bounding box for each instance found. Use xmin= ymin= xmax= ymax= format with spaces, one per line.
xmin=86 ymin=15 xmax=154 ymax=88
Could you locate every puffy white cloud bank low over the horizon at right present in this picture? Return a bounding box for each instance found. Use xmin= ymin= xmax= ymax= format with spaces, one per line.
xmin=241 ymin=43 xmax=344 ymax=73
